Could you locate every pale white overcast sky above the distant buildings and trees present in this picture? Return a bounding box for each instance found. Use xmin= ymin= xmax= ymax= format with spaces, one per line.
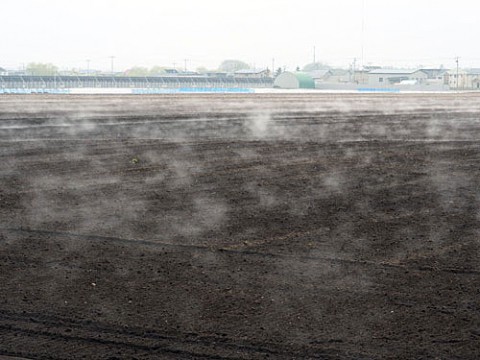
xmin=0 ymin=0 xmax=480 ymax=70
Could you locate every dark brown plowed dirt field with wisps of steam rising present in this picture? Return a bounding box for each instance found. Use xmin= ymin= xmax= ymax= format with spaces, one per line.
xmin=0 ymin=94 xmax=480 ymax=359
